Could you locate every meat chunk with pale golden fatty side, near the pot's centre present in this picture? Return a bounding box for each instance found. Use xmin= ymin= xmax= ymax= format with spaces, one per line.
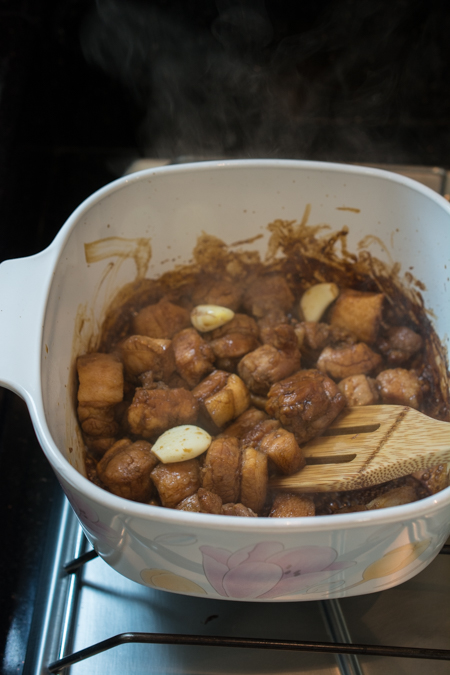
xmin=192 ymin=370 xmax=250 ymax=429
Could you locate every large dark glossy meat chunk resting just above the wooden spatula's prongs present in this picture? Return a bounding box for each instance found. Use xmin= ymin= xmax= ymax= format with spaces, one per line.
xmin=266 ymin=369 xmax=345 ymax=444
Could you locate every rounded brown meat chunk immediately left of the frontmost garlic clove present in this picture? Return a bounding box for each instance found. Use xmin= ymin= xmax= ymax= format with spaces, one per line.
xmin=97 ymin=438 xmax=158 ymax=503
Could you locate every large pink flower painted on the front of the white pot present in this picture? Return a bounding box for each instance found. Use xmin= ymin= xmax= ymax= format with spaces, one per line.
xmin=200 ymin=542 xmax=355 ymax=599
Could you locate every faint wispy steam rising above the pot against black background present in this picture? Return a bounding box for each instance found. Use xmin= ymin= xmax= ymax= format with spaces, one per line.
xmin=81 ymin=0 xmax=444 ymax=161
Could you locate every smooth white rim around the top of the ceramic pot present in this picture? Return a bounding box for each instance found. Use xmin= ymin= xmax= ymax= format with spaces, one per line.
xmin=31 ymin=159 xmax=450 ymax=535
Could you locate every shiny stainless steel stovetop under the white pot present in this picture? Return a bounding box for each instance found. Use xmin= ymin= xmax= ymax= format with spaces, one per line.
xmin=23 ymin=160 xmax=450 ymax=675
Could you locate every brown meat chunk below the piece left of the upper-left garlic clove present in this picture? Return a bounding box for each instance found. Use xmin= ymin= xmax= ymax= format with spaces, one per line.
xmin=120 ymin=335 xmax=175 ymax=380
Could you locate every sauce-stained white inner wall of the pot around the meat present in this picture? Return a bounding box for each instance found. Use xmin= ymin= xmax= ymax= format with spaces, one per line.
xmin=41 ymin=161 xmax=450 ymax=473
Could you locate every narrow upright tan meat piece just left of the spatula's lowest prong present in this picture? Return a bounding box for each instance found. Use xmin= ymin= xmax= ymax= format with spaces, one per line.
xmin=241 ymin=448 xmax=269 ymax=514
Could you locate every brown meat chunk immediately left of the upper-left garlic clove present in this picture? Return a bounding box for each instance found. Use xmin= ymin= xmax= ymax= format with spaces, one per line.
xmin=133 ymin=298 xmax=191 ymax=339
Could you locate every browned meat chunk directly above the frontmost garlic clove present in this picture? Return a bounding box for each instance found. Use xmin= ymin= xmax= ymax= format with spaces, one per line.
xmin=128 ymin=387 xmax=198 ymax=439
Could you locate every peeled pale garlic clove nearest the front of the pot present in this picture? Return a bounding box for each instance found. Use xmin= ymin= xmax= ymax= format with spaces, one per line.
xmin=152 ymin=424 xmax=212 ymax=464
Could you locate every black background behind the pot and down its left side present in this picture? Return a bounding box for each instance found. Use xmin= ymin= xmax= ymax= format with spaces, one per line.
xmin=0 ymin=0 xmax=450 ymax=674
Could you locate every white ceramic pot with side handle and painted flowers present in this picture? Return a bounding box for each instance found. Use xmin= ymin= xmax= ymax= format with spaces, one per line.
xmin=0 ymin=161 xmax=450 ymax=602
